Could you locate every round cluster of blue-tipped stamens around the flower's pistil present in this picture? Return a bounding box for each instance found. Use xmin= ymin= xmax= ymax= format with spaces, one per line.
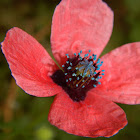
xmin=62 ymin=50 xmax=105 ymax=89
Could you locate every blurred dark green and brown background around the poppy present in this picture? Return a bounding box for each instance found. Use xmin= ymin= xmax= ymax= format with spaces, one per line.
xmin=0 ymin=0 xmax=140 ymax=140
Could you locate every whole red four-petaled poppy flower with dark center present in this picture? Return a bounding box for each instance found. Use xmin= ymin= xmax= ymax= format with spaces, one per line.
xmin=1 ymin=0 xmax=140 ymax=137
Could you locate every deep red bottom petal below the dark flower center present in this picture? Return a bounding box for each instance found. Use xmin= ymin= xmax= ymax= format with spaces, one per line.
xmin=48 ymin=92 xmax=127 ymax=137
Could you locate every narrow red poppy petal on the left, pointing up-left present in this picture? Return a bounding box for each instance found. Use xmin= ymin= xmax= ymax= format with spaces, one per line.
xmin=1 ymin=27 xmax=60 ymax=97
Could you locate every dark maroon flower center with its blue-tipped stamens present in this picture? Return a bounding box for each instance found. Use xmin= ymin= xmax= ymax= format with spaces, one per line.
xmin=52 ymin=50 xmax=104 ymax=102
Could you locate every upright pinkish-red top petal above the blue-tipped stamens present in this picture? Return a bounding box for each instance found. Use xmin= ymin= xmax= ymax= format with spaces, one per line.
xmin=51 ymin=0 xmax=113 ymax=61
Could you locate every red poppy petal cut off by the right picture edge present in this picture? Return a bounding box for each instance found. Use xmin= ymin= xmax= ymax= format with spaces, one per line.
xmin=93 ymin=42 xmax=140 ymax=104
